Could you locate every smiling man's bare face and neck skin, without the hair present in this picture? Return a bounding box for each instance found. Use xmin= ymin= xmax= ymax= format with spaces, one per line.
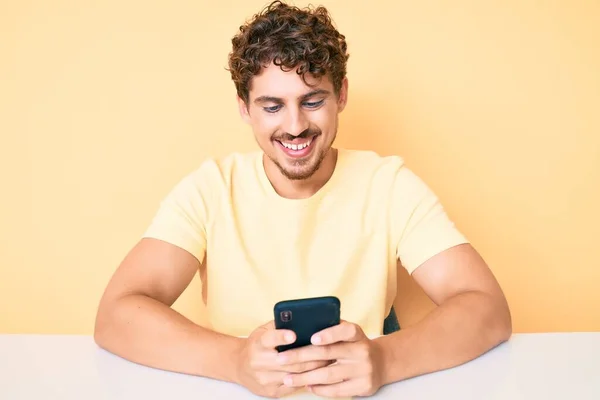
xmin=237 ymin=64 xmax=348 ymax=198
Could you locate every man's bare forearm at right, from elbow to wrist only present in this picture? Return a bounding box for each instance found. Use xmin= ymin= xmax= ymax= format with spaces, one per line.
xmin=375 ymin=292 xmax=512 ymax=384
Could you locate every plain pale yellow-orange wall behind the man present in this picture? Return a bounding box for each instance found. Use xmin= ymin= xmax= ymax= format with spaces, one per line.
xmin=0 ymin=0 xmax=600 ymax=333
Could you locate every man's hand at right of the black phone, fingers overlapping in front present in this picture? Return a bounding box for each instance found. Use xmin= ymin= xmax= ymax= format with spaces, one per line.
xmin=278 ymin=321 xmax=383 ymax=397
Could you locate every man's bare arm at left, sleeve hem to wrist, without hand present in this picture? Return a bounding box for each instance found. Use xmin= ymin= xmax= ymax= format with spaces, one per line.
xmin=94 ymin=238 xmax=243 ymax=381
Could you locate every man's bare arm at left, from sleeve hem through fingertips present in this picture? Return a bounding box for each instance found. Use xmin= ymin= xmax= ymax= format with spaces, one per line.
xmin=94 ymin=238 xmax=328 ymax=397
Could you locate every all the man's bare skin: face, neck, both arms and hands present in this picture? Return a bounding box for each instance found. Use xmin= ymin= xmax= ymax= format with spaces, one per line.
xmin=95 ymin=65 xmax=511 ymax=397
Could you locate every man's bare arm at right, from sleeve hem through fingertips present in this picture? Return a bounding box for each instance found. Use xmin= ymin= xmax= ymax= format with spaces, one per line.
xmin=281 ymin=244 xmax=512 ymax=397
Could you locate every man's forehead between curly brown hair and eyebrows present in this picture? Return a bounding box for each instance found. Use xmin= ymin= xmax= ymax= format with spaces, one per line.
xmin=249 ymin=63 xmax=333 ymax=101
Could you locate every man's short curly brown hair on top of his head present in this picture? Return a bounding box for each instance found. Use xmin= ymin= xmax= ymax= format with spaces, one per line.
xmin=228 ymin=1 xmax=349 ymax=103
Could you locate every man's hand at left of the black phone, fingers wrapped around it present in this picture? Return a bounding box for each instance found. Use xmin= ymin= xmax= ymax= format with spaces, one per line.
xmin=236 ymin=321 xmax=330 ymax=398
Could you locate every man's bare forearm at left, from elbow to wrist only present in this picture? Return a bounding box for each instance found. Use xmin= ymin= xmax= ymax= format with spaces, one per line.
xmin=95 ymin=295 xmax=243 ymax=382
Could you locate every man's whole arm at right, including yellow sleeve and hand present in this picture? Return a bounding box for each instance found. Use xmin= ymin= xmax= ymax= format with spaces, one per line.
xmin=274 ymin=168 xmax=512 ymax=396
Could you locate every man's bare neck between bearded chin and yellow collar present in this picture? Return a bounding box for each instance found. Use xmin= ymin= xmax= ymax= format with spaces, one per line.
xmin=263 ymin=148 xmax=338 ymax=199
